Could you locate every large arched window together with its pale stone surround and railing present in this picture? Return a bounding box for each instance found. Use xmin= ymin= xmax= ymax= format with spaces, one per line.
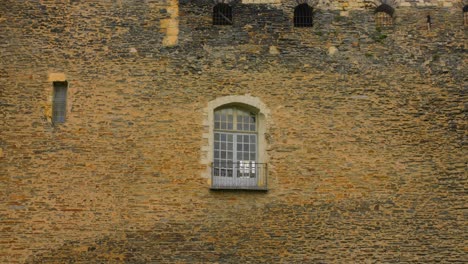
xmin=201 ymin=95 xmax=270 ymax=190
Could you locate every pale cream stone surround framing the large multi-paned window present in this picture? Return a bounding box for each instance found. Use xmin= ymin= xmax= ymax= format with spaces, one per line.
xmin=201 ymin=95 xmax=270 ymax=182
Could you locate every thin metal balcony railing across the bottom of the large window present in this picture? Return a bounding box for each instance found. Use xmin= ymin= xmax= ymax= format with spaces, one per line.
xmin=211 ymin=161 xmax=268 ymax=190
